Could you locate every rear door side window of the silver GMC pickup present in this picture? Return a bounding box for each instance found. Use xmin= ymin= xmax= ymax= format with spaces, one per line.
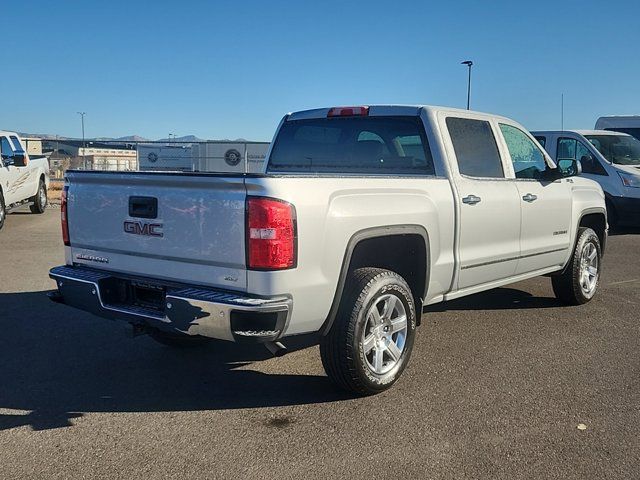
xmin=447 ymin=117 xmax=504 ymax=178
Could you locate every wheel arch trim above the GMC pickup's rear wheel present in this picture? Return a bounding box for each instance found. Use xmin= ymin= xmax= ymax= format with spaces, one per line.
xmin=320 ymin=224 xmax=431 ymax=336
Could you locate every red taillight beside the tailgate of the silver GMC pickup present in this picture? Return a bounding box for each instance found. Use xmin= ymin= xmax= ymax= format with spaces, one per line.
xmin=247 ymin=197 xmax=296 ymax=270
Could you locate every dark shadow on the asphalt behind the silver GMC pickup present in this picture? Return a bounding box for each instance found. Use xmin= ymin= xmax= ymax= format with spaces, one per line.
xmin=0 ymin=292 xmax=350 ymax=430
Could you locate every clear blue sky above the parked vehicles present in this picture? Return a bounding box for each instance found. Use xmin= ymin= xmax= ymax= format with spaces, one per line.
xmin=5 ymin=0 xmax=640 ymax=140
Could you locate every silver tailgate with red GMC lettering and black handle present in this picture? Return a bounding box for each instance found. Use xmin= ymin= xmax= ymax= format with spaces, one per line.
xmin=67 ymin=172 xmax=247 ymax=290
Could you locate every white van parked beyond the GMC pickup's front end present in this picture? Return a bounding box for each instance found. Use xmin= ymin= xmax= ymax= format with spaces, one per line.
xmin=531 ymin=130 xmax=640 ymax=227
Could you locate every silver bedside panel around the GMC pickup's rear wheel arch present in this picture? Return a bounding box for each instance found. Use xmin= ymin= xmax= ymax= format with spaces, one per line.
xmin=246 ymin=176 xmax=454 ymax=335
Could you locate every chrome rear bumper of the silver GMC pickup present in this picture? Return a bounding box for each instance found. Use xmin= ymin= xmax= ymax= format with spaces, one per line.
xmin=49 ymin=266 xmax=292 ymax=343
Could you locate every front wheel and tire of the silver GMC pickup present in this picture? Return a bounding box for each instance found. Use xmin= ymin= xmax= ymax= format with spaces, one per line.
xmin=551 ymin=227 xmax=602 ymax=305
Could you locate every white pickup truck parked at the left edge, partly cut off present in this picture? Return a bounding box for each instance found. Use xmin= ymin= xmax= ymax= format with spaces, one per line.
xmin=0 ymin=131 xmax=49 ymax=229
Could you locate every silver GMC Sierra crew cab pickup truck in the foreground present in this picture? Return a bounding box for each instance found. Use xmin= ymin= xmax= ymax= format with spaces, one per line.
xmin=50 ymin=106 xmax=607 ymax=394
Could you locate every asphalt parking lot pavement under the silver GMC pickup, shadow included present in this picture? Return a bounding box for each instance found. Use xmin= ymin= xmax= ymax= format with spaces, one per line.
xmin=0 ymin=209 xmax=640 ymax=479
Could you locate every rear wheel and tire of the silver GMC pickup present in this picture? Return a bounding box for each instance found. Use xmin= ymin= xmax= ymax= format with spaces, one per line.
xmin=320 ymin=268 xmax=416 ymax=395
